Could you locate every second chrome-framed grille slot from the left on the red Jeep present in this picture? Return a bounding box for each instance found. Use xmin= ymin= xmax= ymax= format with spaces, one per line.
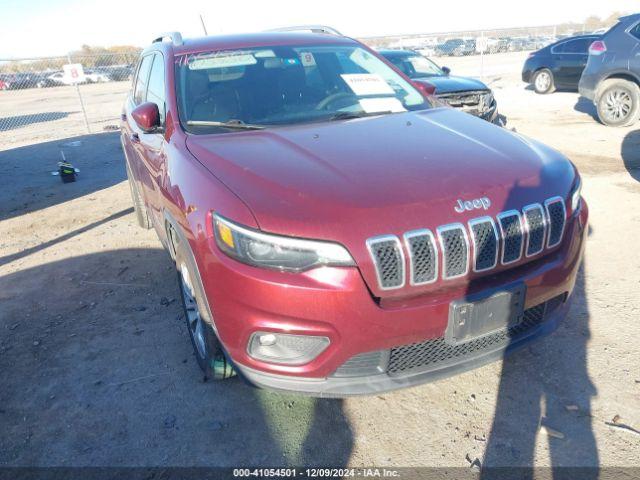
xmin=404 ymin=229 xmax=438 ymax=285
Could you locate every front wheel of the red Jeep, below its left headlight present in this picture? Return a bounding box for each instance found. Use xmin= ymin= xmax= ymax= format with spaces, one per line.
xmin=169 ymin=231 xmax=235 ymax=380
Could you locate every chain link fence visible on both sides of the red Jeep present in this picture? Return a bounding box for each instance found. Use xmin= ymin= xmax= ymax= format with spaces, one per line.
xmin=0 ymin=26 xmax=608 ymax=149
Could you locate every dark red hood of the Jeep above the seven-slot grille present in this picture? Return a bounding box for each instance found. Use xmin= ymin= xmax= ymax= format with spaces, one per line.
xmin=187 ymin=108 xmax=575 ymax=291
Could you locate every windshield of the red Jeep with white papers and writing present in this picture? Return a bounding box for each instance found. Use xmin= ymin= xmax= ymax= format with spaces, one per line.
xmin=176 ymin=45 xmax=429 ymax=133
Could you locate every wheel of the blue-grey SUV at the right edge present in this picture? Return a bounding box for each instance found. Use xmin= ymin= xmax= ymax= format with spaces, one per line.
xmin=596 ymin=78 xmax=640 ymax=127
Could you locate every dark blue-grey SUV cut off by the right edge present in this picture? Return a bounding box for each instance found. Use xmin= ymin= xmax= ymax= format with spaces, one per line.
xmin=579 ymin=13 xmax=640 ymax=127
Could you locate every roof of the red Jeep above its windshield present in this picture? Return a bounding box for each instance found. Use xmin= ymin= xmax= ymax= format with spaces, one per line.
xmin=143 ymin=32 xmax=356 ymax=55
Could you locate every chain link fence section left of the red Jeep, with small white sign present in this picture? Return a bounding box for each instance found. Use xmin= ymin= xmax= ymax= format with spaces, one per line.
xmin=0 ymin=53 xmax=137 ymax=149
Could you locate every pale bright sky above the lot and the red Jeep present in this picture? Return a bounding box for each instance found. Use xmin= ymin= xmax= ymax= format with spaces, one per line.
xmin=0 ymin=0 xmax=640 ymax=60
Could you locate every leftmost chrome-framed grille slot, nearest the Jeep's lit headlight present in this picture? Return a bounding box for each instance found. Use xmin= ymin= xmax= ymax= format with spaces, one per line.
xmin=367 ymin=235 xmax=405 ymax=290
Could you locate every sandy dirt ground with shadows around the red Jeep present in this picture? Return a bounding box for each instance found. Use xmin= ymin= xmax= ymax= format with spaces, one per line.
xmin=0 ymin=57 xmax=640 ymax=467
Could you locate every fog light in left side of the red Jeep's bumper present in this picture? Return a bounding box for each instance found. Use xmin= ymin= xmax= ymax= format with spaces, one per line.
xmin=248 ymin=332 xmax=330 ymax=365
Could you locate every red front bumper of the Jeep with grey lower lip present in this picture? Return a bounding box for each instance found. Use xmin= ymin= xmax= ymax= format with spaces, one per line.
xmin=199 ymin=202 xmax=588 ymax=396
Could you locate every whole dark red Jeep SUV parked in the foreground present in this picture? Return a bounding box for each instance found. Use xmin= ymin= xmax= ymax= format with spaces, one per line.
xmin=122 ymin=27 xmax=588 ymax=396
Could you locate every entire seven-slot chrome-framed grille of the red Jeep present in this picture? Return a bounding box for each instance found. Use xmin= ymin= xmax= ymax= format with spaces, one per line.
xmin=366 ymin=197 xmax=567 ymax=290
